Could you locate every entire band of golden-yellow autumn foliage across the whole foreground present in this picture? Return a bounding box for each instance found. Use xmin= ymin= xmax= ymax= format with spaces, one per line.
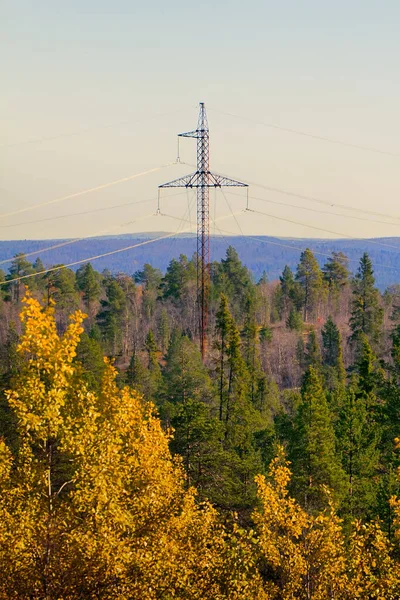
xmin=0 ymin=296 xmax=400 ymax=600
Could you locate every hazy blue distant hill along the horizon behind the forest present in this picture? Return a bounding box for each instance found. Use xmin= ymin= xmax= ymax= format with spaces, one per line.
xmin=0 ymin=233 xmax=400 ymax=290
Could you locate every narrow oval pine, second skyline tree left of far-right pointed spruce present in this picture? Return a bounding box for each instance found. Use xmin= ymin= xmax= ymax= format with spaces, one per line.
xmin=296 ymin=248 xmax=323 ymax=322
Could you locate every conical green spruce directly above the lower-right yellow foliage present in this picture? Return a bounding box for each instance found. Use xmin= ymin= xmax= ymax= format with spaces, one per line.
xmin=291 ymin=367 xmax=344 ymax=511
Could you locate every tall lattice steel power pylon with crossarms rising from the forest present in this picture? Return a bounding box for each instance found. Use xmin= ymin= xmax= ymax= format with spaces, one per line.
xmin=159 ymin=102 xmax=247 ymax=360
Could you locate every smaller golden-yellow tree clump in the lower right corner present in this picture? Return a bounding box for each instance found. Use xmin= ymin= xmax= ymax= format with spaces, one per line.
xmin=254 ymin=449 xmax=400 ymax=600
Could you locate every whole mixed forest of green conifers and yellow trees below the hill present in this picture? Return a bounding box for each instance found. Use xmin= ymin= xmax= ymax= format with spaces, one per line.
xmin=0 ymin=246 xmax=400 ymax=600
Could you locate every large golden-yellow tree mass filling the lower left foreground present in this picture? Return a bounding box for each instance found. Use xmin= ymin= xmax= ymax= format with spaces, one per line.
xmin=0 ymin=296 xmax=267 ymax=600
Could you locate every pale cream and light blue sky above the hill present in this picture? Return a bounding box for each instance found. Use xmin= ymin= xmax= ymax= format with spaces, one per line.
xmin=0 ymin=0 xmax=400 ymax=240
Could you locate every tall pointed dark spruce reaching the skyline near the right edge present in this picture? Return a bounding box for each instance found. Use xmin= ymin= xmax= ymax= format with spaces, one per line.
xmin=349 ymin=252 xmax=383 ymax=345
